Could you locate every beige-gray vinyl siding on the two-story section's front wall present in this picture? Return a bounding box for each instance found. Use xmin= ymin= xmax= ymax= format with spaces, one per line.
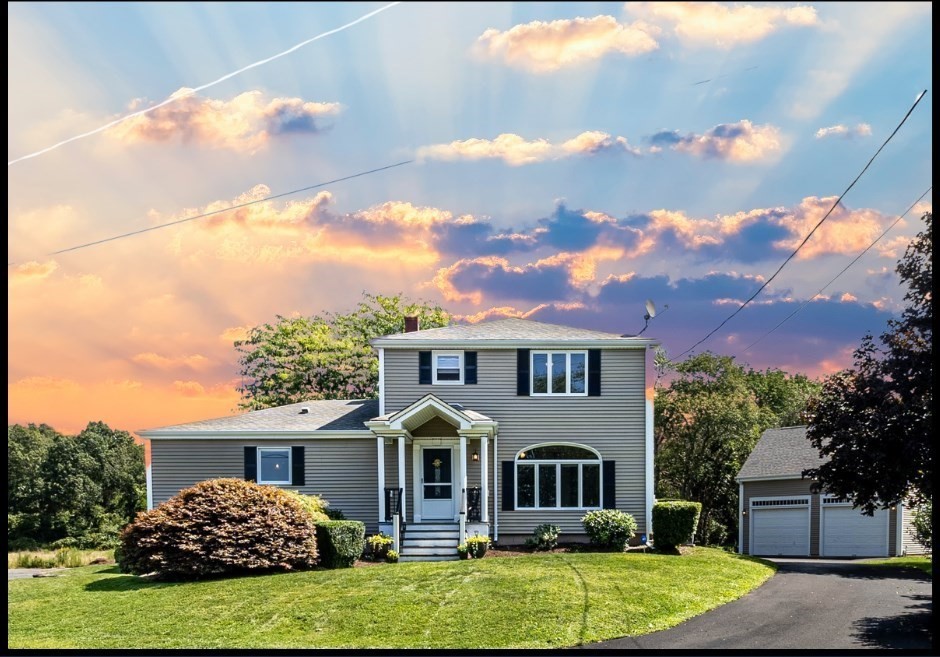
xmin=385 ymin=345 xmax=647 ymax=538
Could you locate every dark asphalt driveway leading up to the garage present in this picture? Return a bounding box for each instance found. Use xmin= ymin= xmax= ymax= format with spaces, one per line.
xmin=582 ymin=559 xmax=933 ymax=650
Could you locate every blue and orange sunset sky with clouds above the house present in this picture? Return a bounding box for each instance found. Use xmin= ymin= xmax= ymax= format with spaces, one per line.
xmin=7 ymin=2 xmax=934 ymax=432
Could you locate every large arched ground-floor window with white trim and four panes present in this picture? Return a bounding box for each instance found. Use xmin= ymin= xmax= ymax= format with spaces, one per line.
xmin=515 ymin=444 xmax=602 ymax=510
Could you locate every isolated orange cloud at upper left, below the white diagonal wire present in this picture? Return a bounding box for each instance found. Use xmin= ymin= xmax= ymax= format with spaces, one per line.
xmin=106 ymin=87 xmax=342 ymax=153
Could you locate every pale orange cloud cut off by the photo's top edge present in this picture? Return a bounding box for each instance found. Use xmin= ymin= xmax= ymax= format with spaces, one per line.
xmin=625 ymin=2 xmax=819 ymax=48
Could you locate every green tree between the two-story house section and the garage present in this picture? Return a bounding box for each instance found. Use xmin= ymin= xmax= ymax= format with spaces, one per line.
xmin=654 ymin=352 xmax=818 ymax=544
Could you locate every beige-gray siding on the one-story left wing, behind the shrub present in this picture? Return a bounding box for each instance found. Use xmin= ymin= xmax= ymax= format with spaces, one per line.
xmin=151 ymin=438 xmax=378 ymax=533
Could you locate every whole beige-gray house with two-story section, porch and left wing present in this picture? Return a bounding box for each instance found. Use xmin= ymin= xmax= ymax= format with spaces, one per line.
xmin=140 ymin=318 xmax=657 ymax=559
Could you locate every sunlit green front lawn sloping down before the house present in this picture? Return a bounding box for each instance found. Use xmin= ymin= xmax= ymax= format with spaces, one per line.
xmin=7 ymin=548 xmax=773 ymax=649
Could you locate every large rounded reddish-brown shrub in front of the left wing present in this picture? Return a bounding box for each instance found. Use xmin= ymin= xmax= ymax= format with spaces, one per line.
xmin=117 ymin=479 xmax=317 ymax=579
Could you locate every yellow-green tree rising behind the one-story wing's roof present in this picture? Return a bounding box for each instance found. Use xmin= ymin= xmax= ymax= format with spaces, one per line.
xmin=235 ymin=293 xmax=450 ymax=410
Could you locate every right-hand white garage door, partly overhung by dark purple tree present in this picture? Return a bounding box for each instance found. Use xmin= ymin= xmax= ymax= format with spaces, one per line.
xmin=820 ymin=498 xmax=888 ymax=557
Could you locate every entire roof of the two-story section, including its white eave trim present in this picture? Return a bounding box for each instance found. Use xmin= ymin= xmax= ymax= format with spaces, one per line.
xmin=372 ymin=317 xmax=656 ymax=348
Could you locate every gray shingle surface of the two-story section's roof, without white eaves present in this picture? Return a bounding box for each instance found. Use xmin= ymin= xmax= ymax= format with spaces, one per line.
xmin=379 ymin=317 xmax=632 ymax=342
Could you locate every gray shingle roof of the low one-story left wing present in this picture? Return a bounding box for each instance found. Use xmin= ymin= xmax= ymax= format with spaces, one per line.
xmin=139 ymin=399 xmax=379 ymax=436
